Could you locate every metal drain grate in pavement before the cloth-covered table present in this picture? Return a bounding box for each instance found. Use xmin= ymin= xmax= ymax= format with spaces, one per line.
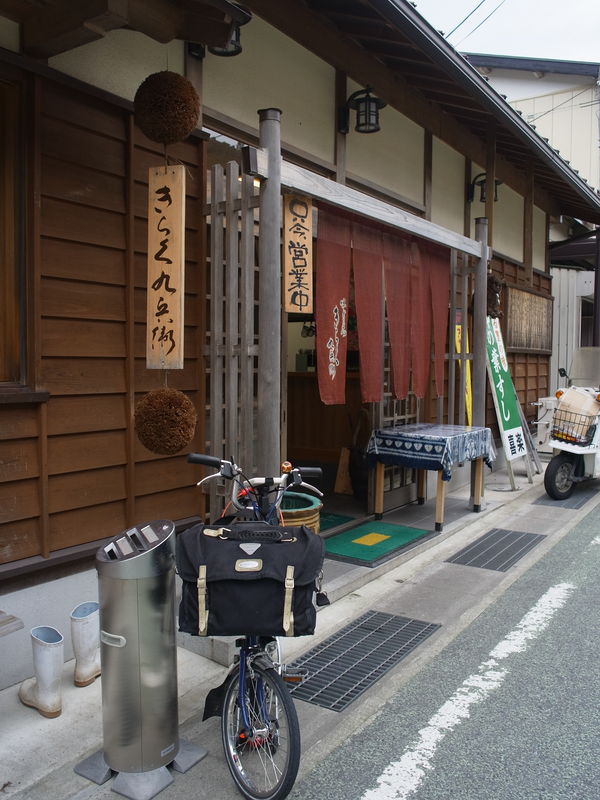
xmin=447 ymin=528 xmax=546 ymax=572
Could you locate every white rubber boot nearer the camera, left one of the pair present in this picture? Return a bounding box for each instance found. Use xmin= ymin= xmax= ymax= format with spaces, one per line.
xmin=19 ymin=625 xmax=64 ymax=718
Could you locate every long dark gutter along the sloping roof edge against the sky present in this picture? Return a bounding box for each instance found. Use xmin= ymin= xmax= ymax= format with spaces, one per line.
xmin=369 ymin=0 xmax=600 ymax=212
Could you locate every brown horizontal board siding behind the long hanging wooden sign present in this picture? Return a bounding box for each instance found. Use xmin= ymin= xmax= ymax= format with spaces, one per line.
xmin=0 ymin=72 xmax=204 ymax=564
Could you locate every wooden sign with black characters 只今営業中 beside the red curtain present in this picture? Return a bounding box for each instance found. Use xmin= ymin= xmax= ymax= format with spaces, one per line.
xmin=283 ymin=194 xmax=313 ymax=314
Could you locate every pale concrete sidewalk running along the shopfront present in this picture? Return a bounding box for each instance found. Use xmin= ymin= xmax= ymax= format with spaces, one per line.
xmin=0 ymin=456 xmax=600 ymax=800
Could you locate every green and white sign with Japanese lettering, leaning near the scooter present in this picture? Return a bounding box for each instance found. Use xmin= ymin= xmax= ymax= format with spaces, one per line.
xmin=486 ymin=317 xmax=527 ymax=461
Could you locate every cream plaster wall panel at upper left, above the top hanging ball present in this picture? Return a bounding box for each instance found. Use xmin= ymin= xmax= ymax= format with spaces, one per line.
xmin=48 ymin=30 xmax=184 ymax=100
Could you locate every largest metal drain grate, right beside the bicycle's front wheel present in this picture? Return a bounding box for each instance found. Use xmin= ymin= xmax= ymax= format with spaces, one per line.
xmin=292 ymin=611 xmax=441 ymax=711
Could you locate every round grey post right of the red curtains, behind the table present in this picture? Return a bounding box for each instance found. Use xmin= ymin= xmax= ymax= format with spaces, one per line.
xmin=473 ymin=217 xmax=488 ymax=426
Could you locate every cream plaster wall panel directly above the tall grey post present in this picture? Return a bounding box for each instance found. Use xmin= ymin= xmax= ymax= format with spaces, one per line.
xmin=203 ymin=17 xmax=336 ymax=162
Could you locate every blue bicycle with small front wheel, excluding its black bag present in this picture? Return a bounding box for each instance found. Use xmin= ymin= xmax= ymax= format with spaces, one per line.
xmin=180 ymin=453 xmax=329 ymax=800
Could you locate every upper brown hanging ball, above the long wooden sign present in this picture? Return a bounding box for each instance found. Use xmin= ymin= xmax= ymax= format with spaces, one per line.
xmin=133 ymin=70 xmax=200 ymax=144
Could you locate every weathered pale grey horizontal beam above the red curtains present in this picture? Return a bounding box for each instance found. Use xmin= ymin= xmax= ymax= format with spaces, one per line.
xmin=256 ymin=149 xmax=482 ymax=258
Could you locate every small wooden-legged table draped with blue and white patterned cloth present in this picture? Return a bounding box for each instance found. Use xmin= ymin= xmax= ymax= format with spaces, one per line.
xmin=367 ymin=423 xmax=495 ymax=530
